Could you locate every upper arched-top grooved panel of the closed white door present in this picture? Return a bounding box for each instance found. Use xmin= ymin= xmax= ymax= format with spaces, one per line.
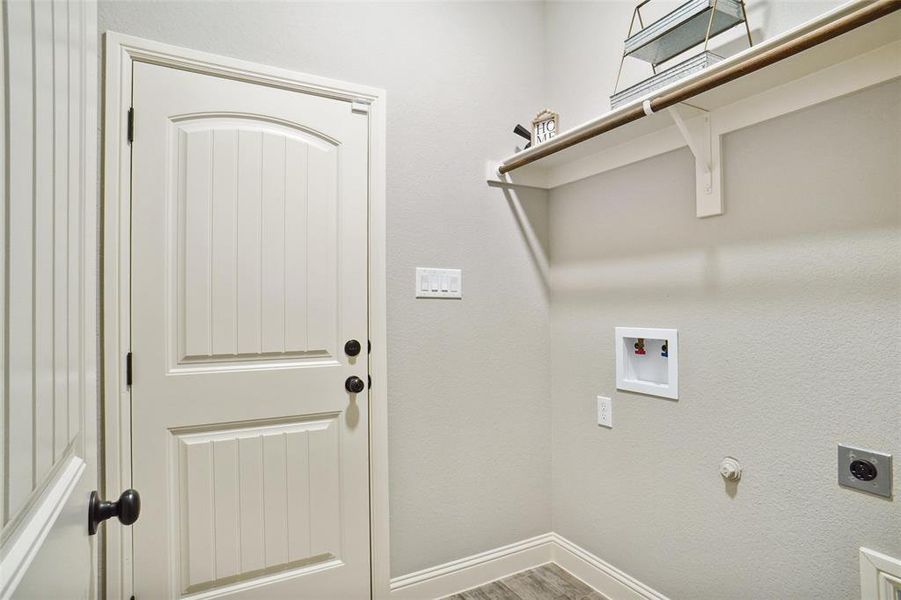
xmin=170 ymin=117 xmax=338 ymax=368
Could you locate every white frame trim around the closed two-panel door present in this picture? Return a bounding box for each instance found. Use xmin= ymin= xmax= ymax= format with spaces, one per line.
xmin=102 ymin=32 xmax=390 ymax=598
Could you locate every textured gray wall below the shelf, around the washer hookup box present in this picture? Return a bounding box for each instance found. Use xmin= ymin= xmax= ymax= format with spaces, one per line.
xmin=550 ymin=82 xmax=901 ymax=600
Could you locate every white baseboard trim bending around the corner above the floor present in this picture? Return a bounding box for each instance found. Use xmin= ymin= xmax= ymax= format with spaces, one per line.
xmin=391 ymin=533 xmax=668 ymax=600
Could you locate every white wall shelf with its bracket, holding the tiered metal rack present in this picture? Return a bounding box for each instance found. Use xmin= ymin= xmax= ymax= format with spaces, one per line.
xmin=486 ymin=1 xmax=901 ymax=216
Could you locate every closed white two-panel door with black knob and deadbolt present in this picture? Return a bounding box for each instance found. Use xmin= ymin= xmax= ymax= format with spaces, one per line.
xmin=131 ymin=62 xmax=370 ymax=599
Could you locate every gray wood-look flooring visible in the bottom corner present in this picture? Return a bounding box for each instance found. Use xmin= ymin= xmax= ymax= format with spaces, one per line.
xmin=444 ymin=563 xmax=605 ymax=600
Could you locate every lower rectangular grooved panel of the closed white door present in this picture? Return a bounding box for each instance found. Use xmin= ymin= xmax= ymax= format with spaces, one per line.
xmin=172 ymin=414 xmax=342 ymax=592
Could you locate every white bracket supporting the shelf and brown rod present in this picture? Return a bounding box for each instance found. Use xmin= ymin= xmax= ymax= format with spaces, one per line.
xmin=666 ymin=106 xmax=723 ymax=218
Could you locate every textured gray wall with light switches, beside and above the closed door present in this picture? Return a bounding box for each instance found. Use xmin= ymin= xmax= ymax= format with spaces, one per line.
xmin=99 ymin=2 xmax=551 ymax=575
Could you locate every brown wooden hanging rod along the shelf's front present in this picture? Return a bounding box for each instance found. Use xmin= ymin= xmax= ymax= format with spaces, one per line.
xmin=497 ymin=0 xmax=901 ymax=175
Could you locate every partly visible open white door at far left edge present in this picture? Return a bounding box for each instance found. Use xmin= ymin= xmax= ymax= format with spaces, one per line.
xmin=0 ymin=0 xmax=102 ymax=599
